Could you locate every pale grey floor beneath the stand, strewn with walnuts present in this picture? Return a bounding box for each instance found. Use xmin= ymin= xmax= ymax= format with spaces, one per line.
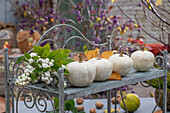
xmin=12 ymin=98 xmax=160 ymax=113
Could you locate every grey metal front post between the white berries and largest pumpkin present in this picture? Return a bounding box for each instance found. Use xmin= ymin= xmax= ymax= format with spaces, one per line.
xmin=58 ymin=68 xmax=64 ymax=113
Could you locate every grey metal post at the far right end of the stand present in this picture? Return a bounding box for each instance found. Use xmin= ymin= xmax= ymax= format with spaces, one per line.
xmin=163 ymin=50 xmax=167 ymax=113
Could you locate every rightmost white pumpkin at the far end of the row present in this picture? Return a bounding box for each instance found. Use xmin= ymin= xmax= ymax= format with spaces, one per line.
xmin=131 ymin=50 xmax=154 ymax=71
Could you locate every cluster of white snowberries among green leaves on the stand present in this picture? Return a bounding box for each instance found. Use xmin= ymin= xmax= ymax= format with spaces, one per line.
xmin=15 ymin=53 xmax=54 ymax=87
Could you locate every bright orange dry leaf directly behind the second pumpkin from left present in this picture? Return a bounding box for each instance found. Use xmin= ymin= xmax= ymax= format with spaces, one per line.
xmin=85 ymin=48 xmax=100 ymax=60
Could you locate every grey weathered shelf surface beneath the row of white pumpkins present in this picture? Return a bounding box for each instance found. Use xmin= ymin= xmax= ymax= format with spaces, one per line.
xmin=28 ymin=69 xmax=165 ymax=100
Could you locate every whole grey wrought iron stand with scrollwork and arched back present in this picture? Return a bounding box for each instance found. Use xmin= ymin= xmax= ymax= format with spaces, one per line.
xmin=4 ymin=24 xmax=167 ymax=113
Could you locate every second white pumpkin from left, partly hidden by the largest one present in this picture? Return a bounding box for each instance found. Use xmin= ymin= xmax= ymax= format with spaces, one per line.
xmin=89 ymin=53 xmax=113 ymax=81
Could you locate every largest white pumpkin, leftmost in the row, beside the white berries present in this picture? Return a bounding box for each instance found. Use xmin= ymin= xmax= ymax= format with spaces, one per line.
xmin=66 ymin=55 xmax=96 ymax=87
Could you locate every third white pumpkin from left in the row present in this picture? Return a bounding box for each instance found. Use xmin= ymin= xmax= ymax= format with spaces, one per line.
xmin=109 ymin=54 xmax=133 ymax=76
